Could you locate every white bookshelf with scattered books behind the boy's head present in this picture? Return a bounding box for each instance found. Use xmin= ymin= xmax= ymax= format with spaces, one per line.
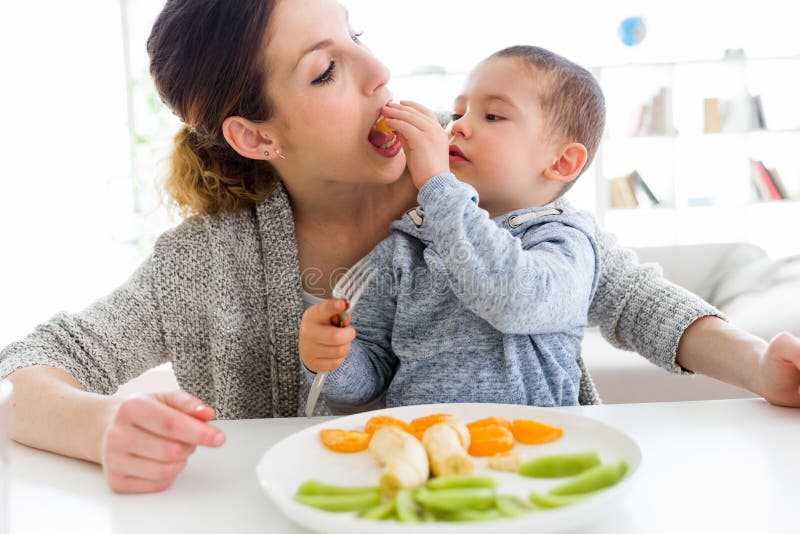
xmin=582 ymin=56 xmax=800 ymax=255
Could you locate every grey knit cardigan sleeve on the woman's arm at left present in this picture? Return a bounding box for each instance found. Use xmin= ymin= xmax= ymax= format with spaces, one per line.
xmin=0 ymin=256 xmax=167 ymax=394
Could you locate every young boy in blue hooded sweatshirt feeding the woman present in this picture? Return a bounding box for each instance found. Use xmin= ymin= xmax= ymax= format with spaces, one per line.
xmin=300 ymin=46 xmax=605 ymax=407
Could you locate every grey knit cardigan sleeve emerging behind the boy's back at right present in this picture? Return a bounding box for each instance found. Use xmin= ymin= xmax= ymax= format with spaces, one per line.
xmin=589 ymin=230 xmax=724 ymax=374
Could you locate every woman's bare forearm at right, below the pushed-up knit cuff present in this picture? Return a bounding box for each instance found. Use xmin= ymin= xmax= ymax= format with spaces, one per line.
xmin=677 ymin=316 xmax=767 ymax=394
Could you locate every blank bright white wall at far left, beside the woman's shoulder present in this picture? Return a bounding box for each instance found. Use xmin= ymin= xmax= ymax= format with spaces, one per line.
xmin=0 ymin=0 xmax=136 ymax=347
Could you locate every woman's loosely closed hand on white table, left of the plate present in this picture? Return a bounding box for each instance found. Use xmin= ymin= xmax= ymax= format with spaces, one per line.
xmin=100 ymin=391 xmax=225 ymax=493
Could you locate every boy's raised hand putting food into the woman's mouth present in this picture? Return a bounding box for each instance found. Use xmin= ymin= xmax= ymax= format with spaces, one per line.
xmin=383 ymin=100 xmax=450 ymax=189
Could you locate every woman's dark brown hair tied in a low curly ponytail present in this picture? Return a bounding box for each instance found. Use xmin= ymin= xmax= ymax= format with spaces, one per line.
xmin=147 ymin=0 xmax=278 ymax=216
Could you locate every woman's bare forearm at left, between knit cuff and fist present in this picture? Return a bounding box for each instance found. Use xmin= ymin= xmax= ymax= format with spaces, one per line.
xmin=8 ymin=366 xmax=119 ymax=462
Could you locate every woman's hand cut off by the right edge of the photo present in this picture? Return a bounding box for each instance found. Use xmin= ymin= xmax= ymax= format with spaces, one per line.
xmin=757 ymin=332 xmax=800 ymax=408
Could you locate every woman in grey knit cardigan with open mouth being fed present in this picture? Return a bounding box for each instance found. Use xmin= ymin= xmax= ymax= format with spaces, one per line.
xmin=0 ymin=0 xmax=800 ymax=492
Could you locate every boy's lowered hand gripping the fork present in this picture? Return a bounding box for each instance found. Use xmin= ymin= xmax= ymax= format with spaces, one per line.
xmin=298 ymin=299 xmax=356 ymax=373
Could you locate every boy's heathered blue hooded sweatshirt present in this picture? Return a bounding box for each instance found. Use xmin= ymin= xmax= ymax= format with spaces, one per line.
xmin=307 ymin=173 xmax=600 ymax=407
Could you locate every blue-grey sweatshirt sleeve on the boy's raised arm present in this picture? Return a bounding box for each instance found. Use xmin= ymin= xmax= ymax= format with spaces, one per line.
xmin=418 ymin=173 xmax=597 ymax=334
